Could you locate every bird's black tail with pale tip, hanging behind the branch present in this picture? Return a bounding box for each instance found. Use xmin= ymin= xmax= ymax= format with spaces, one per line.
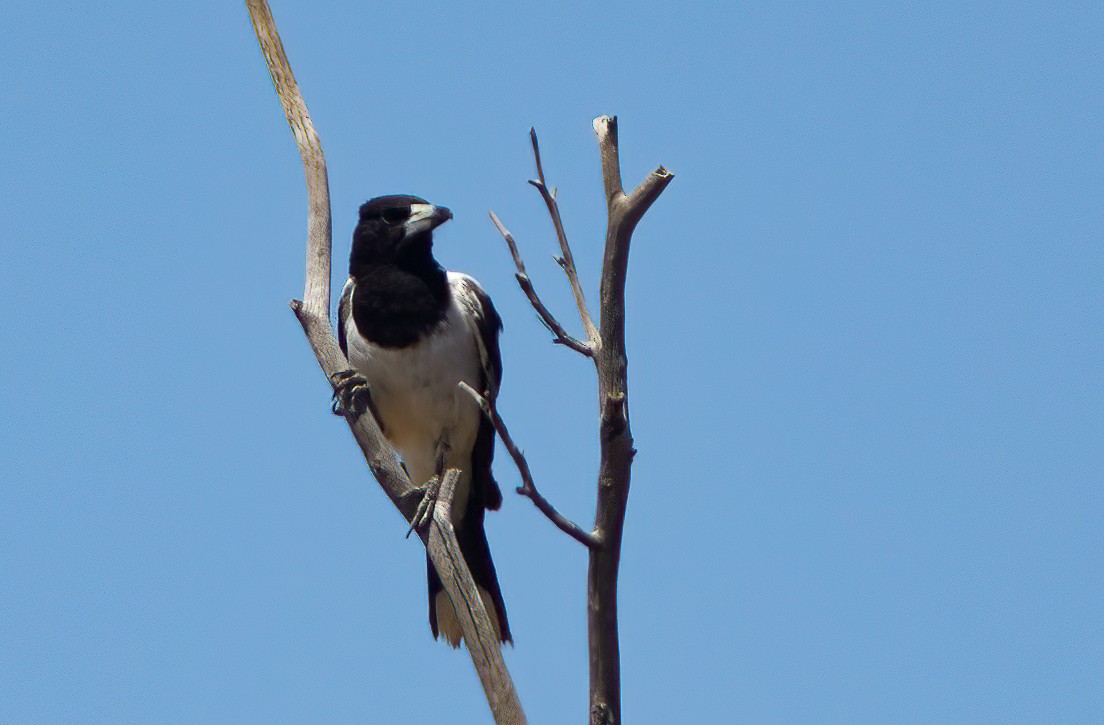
xmin=425 ymin=511 xmax=513 ymax=648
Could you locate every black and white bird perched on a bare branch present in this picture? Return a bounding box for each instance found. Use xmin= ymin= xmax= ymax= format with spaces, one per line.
xmin=336 ymin=195 xmax=512 ymax=647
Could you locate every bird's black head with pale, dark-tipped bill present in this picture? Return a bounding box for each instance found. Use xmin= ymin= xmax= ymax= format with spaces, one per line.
xmin=349 ymin=195 xmax=453 ymax=275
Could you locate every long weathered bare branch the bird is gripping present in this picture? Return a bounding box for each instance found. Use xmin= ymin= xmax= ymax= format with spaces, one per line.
xmin=246 ymin=0 xmax=526 ymax=725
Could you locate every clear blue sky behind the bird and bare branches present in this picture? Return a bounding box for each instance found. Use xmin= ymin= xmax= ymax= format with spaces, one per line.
xmin=0 ymin=0 xmax=1104 ymax=724
